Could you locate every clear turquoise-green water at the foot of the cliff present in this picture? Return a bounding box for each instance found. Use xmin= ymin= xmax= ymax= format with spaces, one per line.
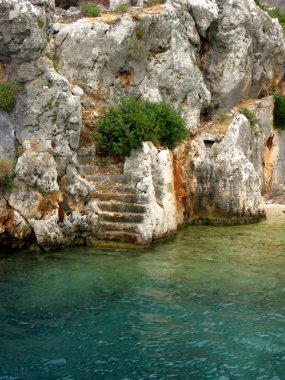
xmin=0 ymin=222 xmax=285 ymax=380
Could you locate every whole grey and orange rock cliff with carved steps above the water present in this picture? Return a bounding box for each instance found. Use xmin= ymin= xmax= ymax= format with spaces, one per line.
xmin=0 ymin=0 xmax=285 ymax=249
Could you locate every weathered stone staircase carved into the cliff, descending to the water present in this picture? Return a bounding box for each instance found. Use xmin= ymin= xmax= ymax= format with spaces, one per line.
xmin=78 ymin=150 xmax=147 ymax=244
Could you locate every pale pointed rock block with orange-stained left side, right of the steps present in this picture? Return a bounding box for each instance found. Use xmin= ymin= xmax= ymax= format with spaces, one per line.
xmin=173 ymin=115 xmax=265 ymax=224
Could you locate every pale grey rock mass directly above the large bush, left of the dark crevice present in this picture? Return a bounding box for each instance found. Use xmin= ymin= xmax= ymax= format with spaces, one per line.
xmin=56 ymin=2 xmax=210 ymax=129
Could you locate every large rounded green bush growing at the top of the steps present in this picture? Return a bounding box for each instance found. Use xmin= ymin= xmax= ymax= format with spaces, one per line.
xmin=94 ymin=97 xmax=188 ymax=156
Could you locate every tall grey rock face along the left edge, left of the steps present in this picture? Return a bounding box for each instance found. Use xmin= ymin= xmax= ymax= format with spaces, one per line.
xmin=0 ymin=0 xmax=84 ymax=245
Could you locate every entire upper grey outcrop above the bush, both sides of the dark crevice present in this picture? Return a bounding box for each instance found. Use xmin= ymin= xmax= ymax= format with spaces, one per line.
xmin=56 ymin=0 xmax=284 ymax=131
